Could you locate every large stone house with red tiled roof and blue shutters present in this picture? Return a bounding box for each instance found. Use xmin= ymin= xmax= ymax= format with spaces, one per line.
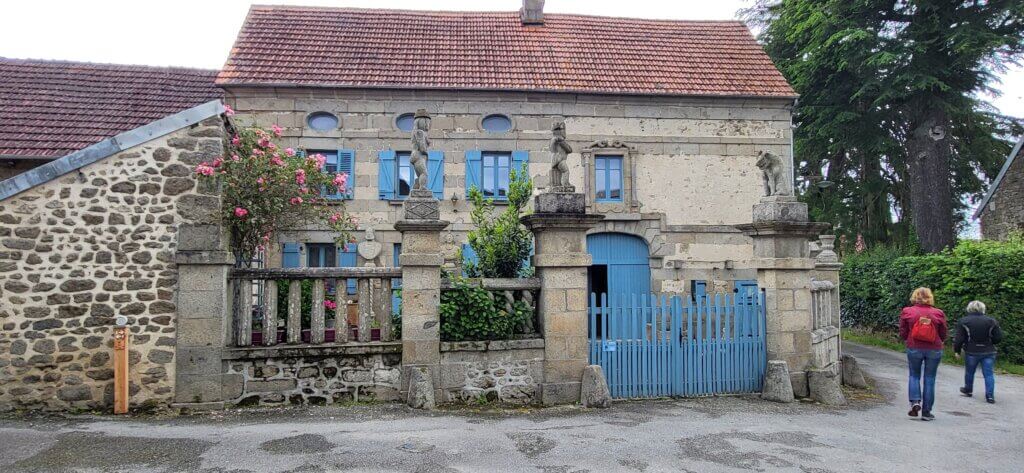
xmin=217 ymin=6 xmax=796 ymax=294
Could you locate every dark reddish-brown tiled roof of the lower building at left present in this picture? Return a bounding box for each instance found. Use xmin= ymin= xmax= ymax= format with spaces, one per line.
xmin=0 ymin=58 xmax=223 ymax=158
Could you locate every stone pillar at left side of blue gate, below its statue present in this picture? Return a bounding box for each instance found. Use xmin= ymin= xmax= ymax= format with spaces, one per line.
xmin=522 ymin=188 xmax=604 ymax=405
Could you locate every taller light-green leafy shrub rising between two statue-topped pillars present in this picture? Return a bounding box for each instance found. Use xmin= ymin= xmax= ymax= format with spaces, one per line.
xmin=459 ymin=165 xmax=534 ymax=277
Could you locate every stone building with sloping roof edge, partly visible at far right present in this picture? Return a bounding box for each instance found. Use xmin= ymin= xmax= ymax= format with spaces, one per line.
xmin=974 ymin=138 xmax=1024 ymax=240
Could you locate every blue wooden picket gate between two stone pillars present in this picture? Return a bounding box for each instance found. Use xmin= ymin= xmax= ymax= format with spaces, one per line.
xmin=589 ymin=291 xmax=767 ymax=398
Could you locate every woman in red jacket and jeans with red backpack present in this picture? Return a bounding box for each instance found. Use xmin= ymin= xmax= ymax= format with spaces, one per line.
xmin=899 ymin=288 xmax=947 ymax=421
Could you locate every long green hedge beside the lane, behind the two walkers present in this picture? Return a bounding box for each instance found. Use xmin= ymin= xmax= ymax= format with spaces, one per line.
xmin=840 ymin=235 xmax=1024 ymax=363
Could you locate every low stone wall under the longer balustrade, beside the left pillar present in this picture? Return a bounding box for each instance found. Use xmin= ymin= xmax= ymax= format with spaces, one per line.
xmin=223 ymin=343 xmax=401 ymax=406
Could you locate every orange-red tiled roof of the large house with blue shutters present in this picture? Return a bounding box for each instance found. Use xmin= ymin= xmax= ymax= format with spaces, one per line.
xmin=217 ymin=6 xmax=796 ymax=97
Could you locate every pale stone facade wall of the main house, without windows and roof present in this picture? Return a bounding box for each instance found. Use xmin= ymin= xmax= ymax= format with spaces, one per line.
xmin=227 ymin=87 xmax=792 ymax=292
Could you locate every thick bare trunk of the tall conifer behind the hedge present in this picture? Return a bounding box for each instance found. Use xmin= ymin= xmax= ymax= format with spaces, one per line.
xmin=906 ymin=106 xmax=956 ymax=253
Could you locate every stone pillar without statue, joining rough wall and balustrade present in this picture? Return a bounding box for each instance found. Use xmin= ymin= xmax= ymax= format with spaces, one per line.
xmin=174 ymin=223 xmax=234 ymax=410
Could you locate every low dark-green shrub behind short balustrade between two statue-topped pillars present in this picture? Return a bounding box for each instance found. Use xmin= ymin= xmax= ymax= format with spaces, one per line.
xmin=440 ymin=278 xmax=534 ymax=342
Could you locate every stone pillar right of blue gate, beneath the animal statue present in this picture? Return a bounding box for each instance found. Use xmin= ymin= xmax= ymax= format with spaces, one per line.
xmin=736 ymin=196 xmax=828 ymax=397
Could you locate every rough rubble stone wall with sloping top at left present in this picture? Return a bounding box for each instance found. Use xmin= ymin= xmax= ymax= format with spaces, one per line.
xmin=0 ymin=118 xmax=223 ymax=410
